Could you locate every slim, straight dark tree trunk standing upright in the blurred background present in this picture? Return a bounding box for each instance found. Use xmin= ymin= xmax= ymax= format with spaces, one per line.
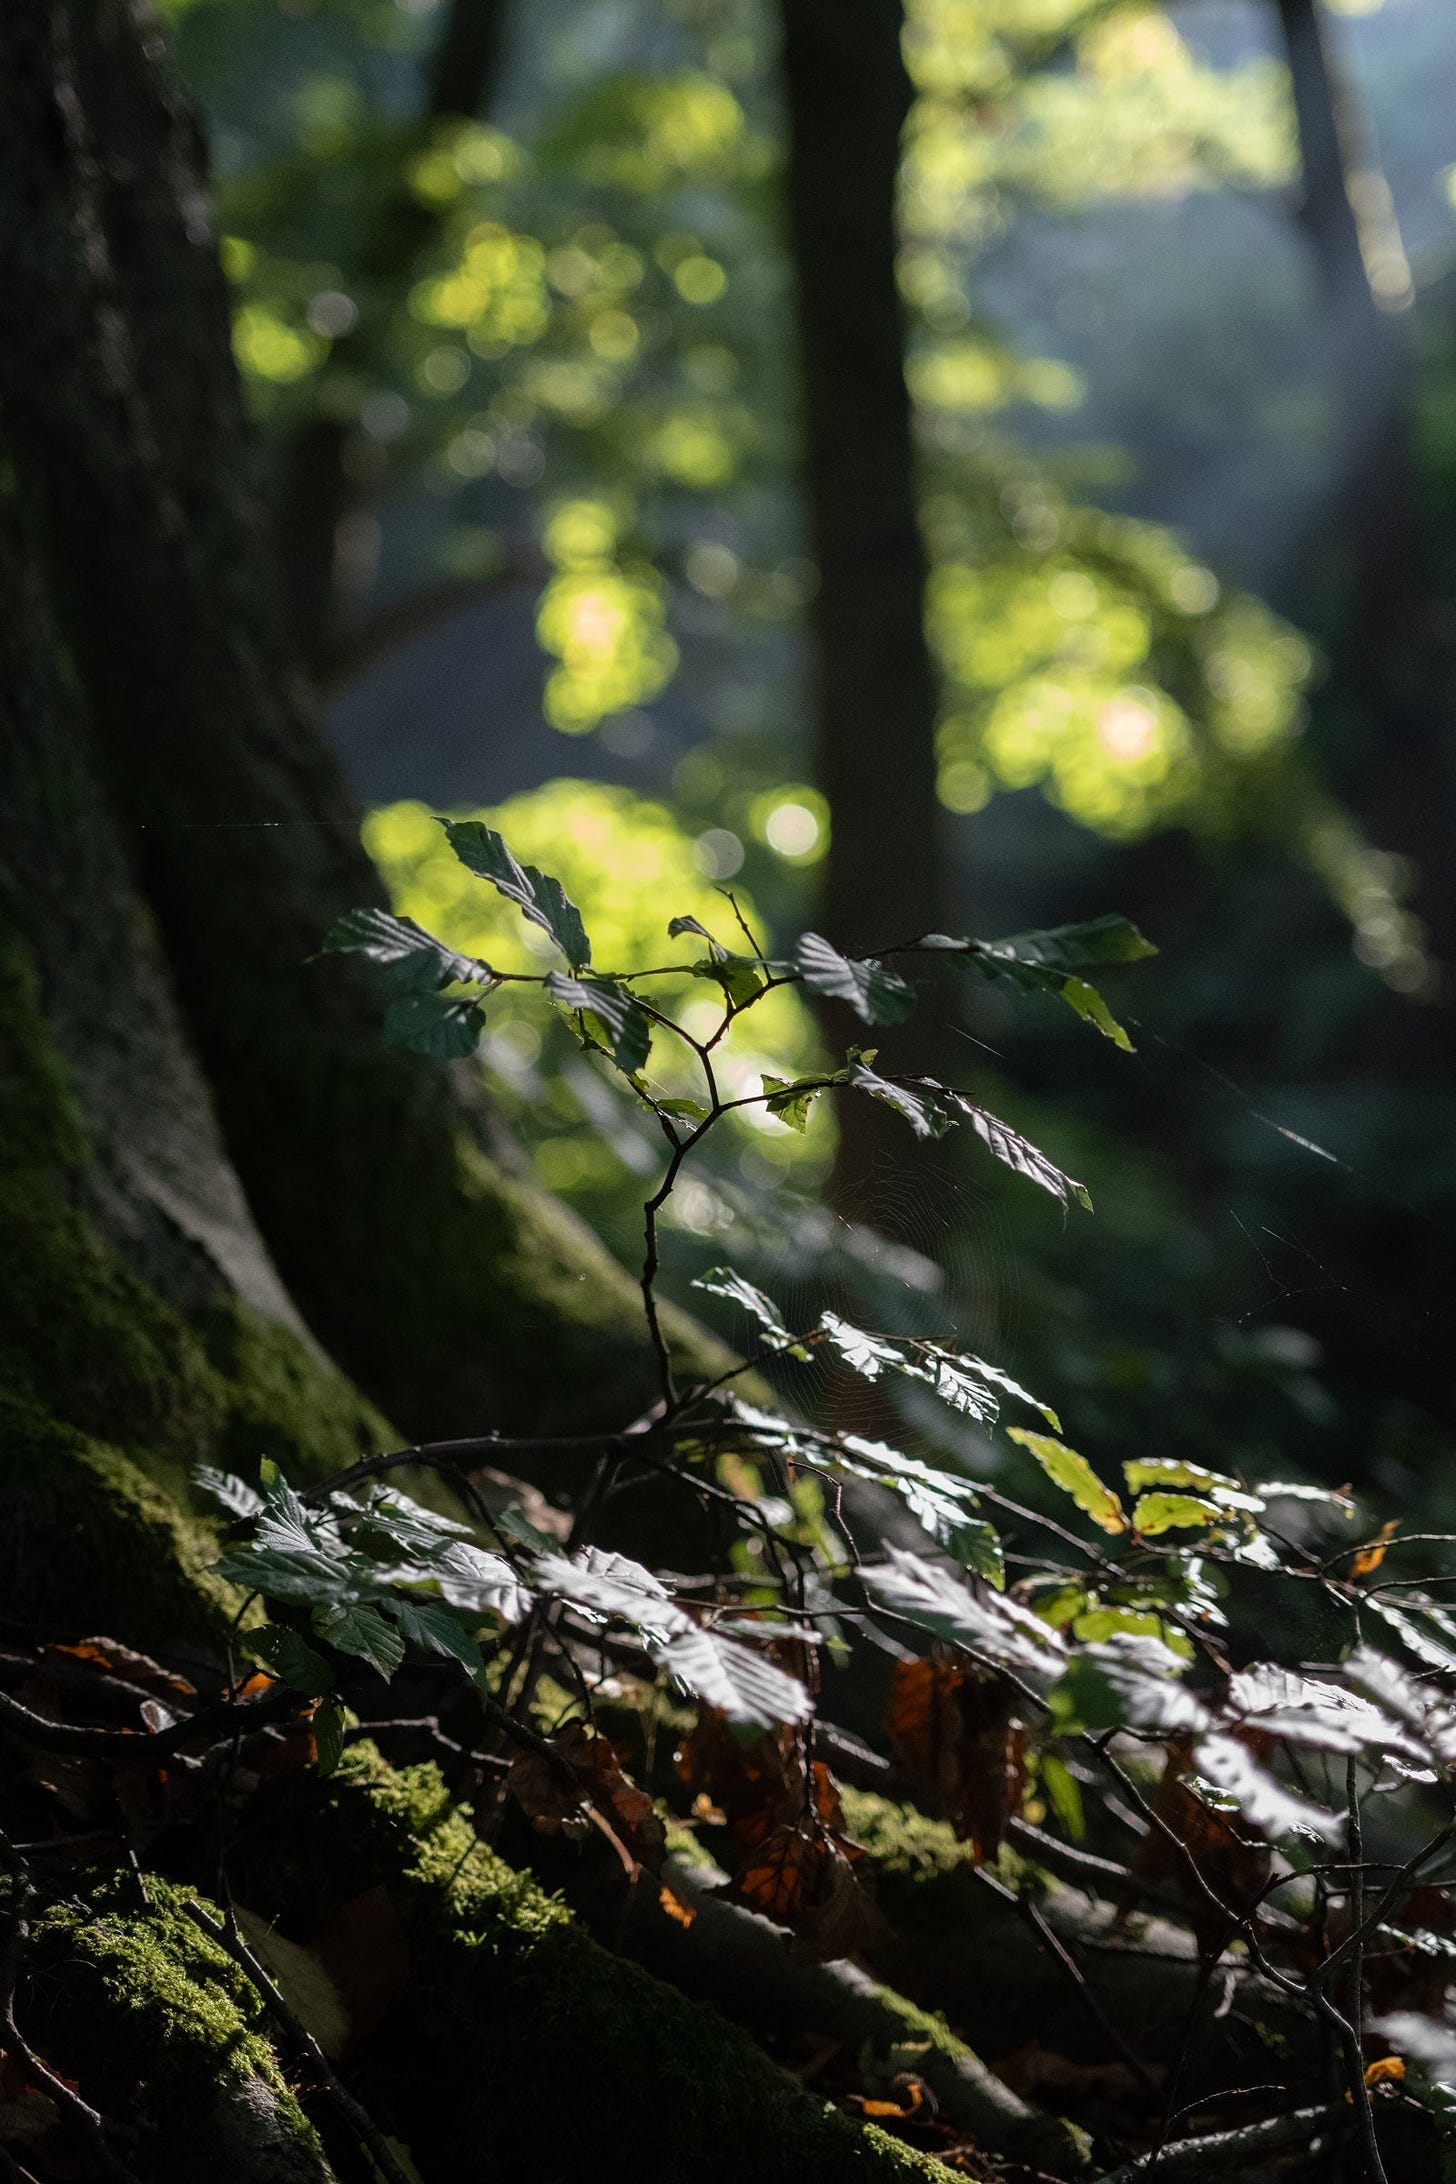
xmin=781 ymin=0 xmax=952 ymax=1221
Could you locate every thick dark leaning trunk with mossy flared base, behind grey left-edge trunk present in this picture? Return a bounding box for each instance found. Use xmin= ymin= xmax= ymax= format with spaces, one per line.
xmin=0 ymin=0 xmax=724 ymax=1467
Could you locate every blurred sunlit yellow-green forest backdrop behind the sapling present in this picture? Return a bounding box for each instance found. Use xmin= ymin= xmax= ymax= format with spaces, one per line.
xmin=166 ymin=0 xmax=1456 ymax=1520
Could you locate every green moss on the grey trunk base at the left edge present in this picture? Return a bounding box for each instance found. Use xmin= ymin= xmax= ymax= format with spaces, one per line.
xmin=0 ymin=924 xmax=403 ymax=1645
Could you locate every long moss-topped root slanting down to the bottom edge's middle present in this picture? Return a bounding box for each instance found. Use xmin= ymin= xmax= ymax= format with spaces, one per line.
xmin=236 ymin=1752 xmax=943 ymax=2184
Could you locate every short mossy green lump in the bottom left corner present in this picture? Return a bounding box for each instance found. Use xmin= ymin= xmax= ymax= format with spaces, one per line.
xmin=28 ymin=1876 xmax=330 ymax=2184
